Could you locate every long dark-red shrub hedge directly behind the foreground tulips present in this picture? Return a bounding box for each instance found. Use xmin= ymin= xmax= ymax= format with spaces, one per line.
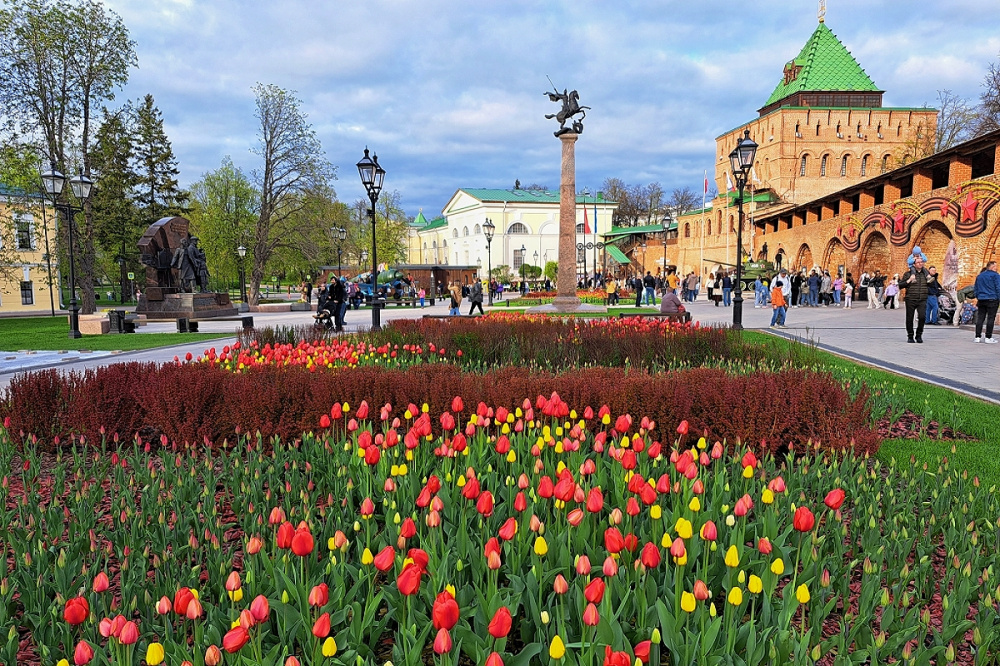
xmin=0 ymin=363 xmax=881 ymax=453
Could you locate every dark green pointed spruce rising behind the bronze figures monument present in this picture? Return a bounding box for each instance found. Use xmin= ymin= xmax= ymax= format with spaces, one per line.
xmin=135 ymin=95 xmax=190 ymax=225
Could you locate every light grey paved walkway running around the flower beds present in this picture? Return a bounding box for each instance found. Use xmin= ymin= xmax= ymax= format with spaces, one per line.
xmin=0 ymin=298 xmax=1000 ymax=403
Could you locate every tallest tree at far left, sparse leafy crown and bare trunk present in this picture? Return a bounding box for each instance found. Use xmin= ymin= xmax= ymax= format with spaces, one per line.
xmin=0 ymin=0 xmax=136 ymax=313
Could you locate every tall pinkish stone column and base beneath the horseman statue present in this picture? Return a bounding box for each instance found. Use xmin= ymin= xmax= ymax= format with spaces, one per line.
xmin=525 ymin=132 xmax=608 ymax=314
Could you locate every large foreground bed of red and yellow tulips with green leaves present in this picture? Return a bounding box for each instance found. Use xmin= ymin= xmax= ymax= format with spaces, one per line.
xmin=0 ymin=394 xmax=1000 ymax=666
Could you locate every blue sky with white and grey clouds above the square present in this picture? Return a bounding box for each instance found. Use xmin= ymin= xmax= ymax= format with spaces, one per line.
xmin=105 ymin=0 xmax=1000 ymax=219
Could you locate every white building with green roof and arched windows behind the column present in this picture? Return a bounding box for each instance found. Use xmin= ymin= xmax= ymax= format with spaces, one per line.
xmin=408 ymin=188 xmax=618 ymax=276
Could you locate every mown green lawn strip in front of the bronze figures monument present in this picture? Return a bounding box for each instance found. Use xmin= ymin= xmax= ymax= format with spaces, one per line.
xmin=0 ymin=315 xmax=235 ymax=351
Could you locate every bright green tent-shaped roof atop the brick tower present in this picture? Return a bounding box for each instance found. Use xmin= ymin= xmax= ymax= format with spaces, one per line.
xmin=764 ymin=23 xmax=881 ymax=108
